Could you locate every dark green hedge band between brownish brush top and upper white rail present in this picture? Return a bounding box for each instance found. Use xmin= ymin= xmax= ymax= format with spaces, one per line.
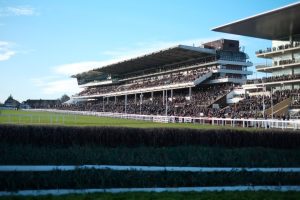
xmin=0 ymin=142 xmax=300 ymax=167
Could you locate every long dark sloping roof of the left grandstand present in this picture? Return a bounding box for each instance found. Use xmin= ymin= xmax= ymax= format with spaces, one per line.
xmin=72 ymin=45 xmax=216 ymax=77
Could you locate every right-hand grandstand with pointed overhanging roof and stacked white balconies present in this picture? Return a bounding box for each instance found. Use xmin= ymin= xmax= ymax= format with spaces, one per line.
xmin=213 ymin=2 xmax=300 ymax=118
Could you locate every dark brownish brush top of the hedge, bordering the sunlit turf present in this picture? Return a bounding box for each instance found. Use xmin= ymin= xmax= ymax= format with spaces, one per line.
xmin=0 ymin=125 xmax=300 ymax=148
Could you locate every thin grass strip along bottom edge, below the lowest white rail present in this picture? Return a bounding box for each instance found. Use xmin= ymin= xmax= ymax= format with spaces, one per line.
xmin=0 ymin=191 xmax=300 ymax=200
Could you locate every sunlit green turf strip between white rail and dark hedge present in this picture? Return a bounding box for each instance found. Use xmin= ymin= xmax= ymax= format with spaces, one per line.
xmin=0 ymin=110 xmax=237 ymax=129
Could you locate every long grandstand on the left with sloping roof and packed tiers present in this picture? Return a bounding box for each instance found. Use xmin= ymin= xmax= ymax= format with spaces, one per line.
xmin=67 ymin=39 xmax=252 ymax=117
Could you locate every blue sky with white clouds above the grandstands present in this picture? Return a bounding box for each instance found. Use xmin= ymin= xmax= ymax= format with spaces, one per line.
xmin=0 ymin=0 xmax=297 ymax=103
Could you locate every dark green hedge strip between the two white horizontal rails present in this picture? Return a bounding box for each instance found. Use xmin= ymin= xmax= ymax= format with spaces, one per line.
xmin=0 ymin=170 xmax=300 ymax=191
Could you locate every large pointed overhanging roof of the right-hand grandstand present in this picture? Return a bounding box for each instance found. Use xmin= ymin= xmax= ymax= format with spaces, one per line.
xmin=212 ymin=2 xmax=300 ymax=40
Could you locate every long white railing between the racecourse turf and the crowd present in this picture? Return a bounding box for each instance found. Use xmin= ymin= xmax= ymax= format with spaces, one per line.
xmin=24 ymin=109 xmax=300 ymax=130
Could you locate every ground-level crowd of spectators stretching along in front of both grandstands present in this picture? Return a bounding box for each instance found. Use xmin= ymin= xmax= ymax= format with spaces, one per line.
xmin=59 ymin=84 xmax=300 ymax=118
